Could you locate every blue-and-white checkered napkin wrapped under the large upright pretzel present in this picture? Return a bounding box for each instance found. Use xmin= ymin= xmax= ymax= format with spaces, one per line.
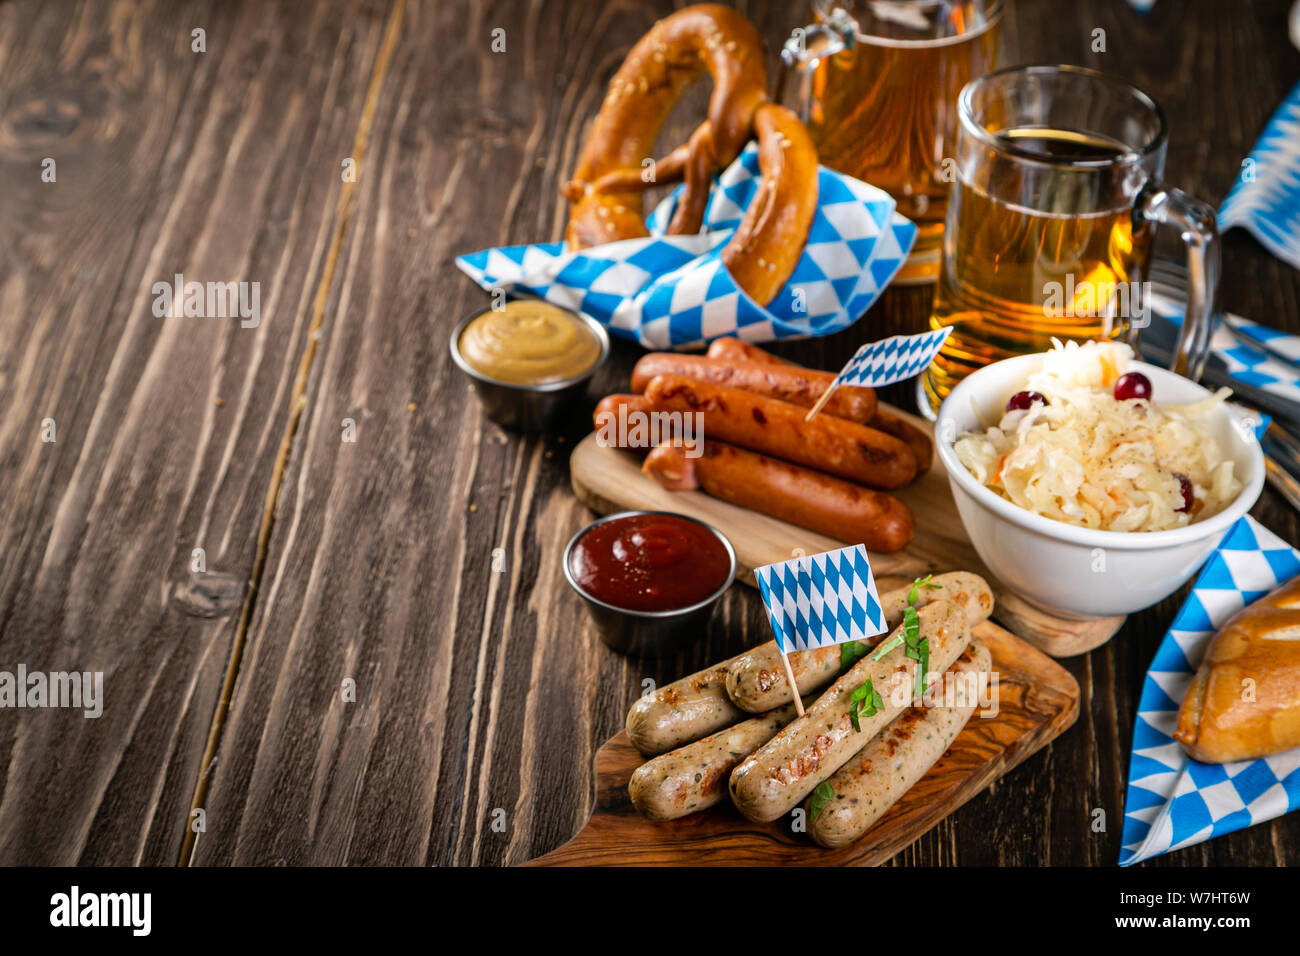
xmin=456 ymin=144 xmax=917 ymax=349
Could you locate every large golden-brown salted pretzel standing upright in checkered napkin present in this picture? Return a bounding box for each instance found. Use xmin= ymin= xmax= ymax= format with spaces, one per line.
xmin=564 ymin=4 xmax=816 ymax=306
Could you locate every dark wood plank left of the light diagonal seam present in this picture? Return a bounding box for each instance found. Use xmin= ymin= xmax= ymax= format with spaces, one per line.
xmin=0 ymin=0 xmax=384 ymax=864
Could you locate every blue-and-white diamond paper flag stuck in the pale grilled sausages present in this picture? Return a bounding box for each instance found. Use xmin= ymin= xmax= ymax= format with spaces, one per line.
xmin=754 ymin=545 xmax=885 ymax=654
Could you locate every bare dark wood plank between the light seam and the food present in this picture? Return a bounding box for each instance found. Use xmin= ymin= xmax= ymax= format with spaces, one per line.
xmin=185 ymin=3 xmax=800 ymax=864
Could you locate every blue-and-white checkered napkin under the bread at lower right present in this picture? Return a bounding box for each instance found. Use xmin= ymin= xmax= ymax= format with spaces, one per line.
xmin=1119 ymin=516 xmax=1300 ymax=866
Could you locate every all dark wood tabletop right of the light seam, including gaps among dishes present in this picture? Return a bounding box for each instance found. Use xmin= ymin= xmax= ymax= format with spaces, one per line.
xmin=189 ymin=0 xmax=1300 ymax=865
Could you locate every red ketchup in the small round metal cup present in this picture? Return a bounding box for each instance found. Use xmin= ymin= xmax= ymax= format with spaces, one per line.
xmin=569 ymin=515 xmax=731 ymax=611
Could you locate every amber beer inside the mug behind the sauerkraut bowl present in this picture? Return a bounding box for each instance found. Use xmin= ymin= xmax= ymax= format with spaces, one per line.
xmin=926 ymin=129 xmax=1156 ymax=407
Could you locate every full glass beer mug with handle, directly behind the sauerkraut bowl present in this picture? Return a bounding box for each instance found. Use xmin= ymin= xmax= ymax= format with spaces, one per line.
xmin=918 ymin=66 xmax=1219 ymax=416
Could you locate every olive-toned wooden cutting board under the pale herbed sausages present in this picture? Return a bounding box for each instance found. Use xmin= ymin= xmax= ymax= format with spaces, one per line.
xmin=527 ymin=622 xmax=1079 ymax=866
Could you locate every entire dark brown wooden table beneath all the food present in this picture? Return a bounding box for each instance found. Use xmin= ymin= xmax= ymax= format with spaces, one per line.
xmin=0 ymin=0 xmax=1300 ymax=866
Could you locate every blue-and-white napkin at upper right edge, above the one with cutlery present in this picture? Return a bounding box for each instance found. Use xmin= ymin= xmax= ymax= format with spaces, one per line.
xmin=1218 ymin=83 xmax=1300 ymax=269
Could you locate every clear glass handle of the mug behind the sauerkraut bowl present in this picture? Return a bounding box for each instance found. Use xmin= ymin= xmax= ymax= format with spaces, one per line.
xmin=1135 ymin=182 xmax=1219 ymax=381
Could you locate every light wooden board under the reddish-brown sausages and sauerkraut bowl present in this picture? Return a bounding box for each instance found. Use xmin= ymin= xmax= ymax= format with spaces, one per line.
xmin=569 ymin=406 xmax=1125 ymax=657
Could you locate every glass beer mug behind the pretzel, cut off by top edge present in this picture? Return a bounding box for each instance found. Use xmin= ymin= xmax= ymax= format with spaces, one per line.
xmin=777 ymin=0 xmax=1004 ymax=284
